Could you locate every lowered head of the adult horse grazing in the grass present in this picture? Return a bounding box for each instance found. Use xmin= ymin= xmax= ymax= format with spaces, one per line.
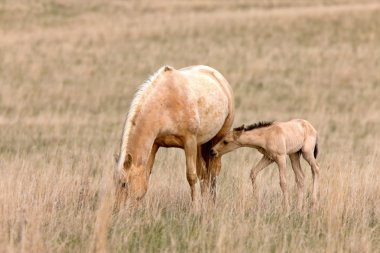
xmin=114 ymin=153 xmax=148 ymax=207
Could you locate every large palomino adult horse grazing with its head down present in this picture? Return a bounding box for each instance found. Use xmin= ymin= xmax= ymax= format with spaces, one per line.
xmin=115 ymin=66 xmax=234 ymax=207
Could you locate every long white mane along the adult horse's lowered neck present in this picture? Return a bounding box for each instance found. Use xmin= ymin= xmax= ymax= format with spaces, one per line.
xmin=117 ymin=66 xmax=166 ymax=171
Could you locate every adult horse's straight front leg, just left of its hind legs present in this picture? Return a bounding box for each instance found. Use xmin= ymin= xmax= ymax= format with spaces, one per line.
xmin=184 ymin=135 xmax=197 ymax=204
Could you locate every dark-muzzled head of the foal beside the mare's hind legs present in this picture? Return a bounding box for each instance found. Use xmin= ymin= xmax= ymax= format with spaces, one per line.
xmin=211 ymin=125 xmax=245 ymax=156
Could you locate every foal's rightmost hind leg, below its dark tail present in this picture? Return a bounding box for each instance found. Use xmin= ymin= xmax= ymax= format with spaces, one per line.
xmin=302 ymin=138 xmax=319 ymax=206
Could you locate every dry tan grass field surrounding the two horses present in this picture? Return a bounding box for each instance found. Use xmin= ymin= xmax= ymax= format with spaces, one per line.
xmin=0 ymin=0 xmax=380 ymax=252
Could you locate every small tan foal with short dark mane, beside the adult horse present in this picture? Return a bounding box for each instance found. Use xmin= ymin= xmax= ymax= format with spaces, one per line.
xmin=211 ymin=119 xmax=319 ymax=211
